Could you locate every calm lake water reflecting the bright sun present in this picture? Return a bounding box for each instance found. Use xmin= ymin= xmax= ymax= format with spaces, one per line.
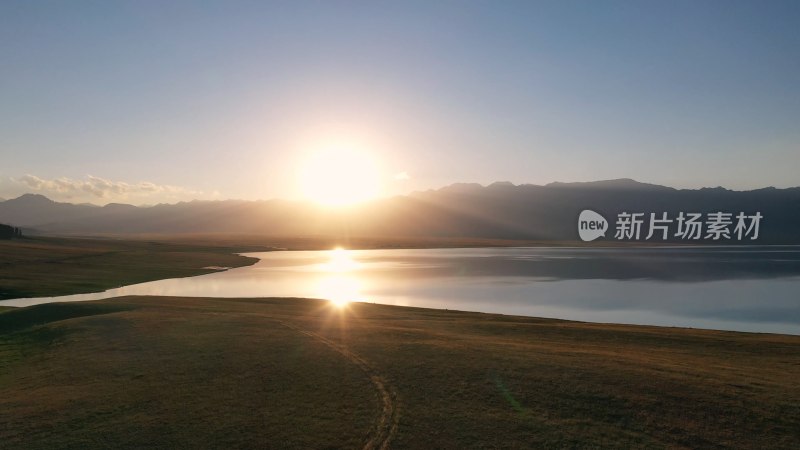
xmin=0 ymin=246 xmax=800 ymax=334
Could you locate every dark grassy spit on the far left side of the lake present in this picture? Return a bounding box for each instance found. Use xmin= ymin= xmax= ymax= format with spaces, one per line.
xmin=0 ymin=237 xmax=269 ymax=300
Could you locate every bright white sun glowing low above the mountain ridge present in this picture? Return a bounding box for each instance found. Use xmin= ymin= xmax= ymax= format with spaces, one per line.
xmin=299 ymin=148 xmax=381 ymax=206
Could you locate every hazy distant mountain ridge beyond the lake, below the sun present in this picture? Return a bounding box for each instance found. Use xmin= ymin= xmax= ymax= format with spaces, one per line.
xmin=0 ymin=179 xmax=800 ymax=244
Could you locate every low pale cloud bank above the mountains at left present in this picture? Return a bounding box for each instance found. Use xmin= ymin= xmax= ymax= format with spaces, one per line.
xmin=11 ymin=174 xmax=202 ymax=202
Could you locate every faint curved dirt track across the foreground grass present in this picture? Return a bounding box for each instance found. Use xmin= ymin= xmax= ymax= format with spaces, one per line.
xmin=279 ymin=321 xmax=399 ymax=450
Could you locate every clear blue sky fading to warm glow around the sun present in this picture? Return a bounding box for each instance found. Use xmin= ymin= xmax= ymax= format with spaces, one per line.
xmin=0 ymin=0 xmax=800 ymax=204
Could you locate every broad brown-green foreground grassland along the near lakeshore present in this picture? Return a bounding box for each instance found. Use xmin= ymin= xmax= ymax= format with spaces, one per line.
xmin=0 ymin=297 xmax=800 ymax=449
